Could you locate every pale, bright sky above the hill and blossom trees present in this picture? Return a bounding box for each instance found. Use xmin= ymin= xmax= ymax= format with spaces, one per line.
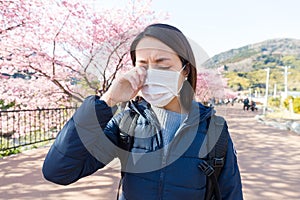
xmin=101 ymin=0 xmax=300 ymax=57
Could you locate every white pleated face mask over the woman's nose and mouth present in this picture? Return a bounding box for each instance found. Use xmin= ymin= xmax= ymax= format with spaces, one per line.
xmin=140 ymin=68 xmax=183 ymax=107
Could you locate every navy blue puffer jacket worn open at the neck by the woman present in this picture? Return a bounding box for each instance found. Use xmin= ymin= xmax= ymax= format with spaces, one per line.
xmin=43 ymin=96 xmax=243 ymax=200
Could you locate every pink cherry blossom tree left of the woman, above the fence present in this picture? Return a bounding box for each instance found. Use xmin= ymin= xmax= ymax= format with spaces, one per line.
xmin=0 ymin=0 xmax=167 ymax=108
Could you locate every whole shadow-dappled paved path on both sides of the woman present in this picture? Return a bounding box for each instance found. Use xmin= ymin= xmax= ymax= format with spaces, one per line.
xmin=0 ymin=105 xmax=300 ymax=200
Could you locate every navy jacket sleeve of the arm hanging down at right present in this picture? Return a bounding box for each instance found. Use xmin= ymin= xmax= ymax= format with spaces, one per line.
xmin=219 ymin=130 xmax=243 ymax=200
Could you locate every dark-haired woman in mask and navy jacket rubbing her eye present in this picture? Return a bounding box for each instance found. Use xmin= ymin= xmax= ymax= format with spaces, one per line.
xmin=43 ymin=24 xmax=243 ymax=200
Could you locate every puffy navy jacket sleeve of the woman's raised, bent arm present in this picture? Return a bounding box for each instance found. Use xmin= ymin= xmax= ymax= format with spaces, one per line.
xmin=42 ymin=96 xmax=118 ymax=185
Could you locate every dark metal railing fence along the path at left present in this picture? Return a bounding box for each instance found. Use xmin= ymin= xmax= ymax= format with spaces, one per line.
xmin=0 ymin=107 xmax=76 ymax=151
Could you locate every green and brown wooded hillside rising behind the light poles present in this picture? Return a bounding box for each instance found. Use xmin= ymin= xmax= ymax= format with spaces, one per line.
xmin=204 ymin=38 xmax=300 ymax=92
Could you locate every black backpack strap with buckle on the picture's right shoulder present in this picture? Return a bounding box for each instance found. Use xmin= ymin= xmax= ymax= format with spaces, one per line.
xmin=199 ymin=115 xmax=229 ymax=200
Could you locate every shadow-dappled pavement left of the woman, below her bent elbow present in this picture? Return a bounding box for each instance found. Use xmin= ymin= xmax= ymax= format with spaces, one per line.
xmin=0 ymin=148 xmax=119 ymax=200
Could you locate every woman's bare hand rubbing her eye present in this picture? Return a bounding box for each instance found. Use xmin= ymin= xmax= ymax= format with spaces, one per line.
xmin=101 ymin=67 xmax=147 ymax=107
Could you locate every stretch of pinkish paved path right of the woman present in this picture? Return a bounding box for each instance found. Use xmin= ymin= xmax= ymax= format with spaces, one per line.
xmin=217 ymin=104 xmax=300 ymax=200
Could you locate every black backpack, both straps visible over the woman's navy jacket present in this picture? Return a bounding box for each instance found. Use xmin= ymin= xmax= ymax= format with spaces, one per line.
xmin=117 ymin=101 xmax=229 ymax=200
